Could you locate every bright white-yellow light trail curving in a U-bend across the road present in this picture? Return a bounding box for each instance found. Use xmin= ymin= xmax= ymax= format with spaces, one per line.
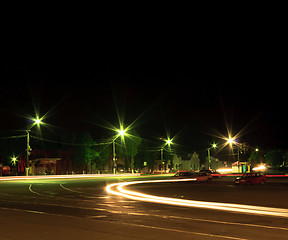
xmin=106 ymin=178 xmax=288 ymax=218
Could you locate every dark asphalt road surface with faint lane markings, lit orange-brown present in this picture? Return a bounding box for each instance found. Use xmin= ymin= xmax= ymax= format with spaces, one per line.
xmin=0 ymin=174 xmax=288 ymax=240
